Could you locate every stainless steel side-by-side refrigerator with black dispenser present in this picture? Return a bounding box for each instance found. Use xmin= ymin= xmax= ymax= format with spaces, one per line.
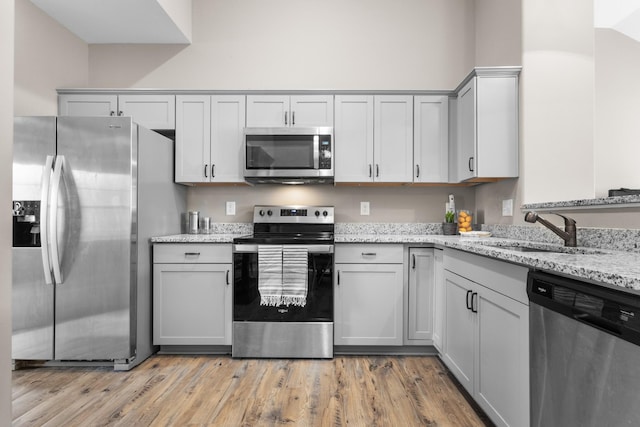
xmin=12 ymin=117 xmax=186 ymax=370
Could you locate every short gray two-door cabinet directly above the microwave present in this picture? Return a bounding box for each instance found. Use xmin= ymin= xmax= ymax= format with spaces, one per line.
xmin=247 ymin=95 xmax=333 ymax=127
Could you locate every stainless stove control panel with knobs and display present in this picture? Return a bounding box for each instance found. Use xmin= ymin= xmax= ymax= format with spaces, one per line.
xmin=253 ymin=206 xmax=334 ymax=224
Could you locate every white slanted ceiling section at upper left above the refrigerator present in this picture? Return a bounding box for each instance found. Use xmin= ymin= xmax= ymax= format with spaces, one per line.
xmin=31 ymin=0 xmax=191 ymax=44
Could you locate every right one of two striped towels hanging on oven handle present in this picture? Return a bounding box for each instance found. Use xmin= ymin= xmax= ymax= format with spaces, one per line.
xmin=281 ymin=246 xmax=309 ymax=307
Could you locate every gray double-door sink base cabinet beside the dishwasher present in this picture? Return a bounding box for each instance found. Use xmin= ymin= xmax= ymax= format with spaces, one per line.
xmin=441 ymin=249 xmax=529 ymax=426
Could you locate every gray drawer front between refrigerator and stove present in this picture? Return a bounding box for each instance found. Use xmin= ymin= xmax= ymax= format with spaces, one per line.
xmin=153 ymin=243 xmax=232 ymax=264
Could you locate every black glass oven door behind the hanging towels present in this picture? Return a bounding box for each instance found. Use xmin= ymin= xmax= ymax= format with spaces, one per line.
xmin=233 ymin=244 xmax=334 ymax=322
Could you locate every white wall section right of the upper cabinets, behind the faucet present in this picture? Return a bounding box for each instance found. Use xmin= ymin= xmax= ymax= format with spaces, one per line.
xmin=520 ymin=0 xmax=594 ymax=203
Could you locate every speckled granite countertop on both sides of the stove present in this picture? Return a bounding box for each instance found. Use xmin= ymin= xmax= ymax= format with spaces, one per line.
xmin=151 ymin=233 xmax=640 ymax=292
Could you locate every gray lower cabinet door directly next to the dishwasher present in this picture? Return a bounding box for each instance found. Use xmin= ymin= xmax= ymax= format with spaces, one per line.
xmin=476 ymin=287 xmax=529 ymax=426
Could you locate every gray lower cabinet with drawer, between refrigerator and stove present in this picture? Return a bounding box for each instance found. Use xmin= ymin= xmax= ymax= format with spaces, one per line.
xmin=153 ymin=243 xmax=233 ymax=346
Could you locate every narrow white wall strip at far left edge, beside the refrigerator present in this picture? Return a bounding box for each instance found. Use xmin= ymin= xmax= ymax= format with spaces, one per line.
xmin=0 ymin=1 xmax=14 ymax=427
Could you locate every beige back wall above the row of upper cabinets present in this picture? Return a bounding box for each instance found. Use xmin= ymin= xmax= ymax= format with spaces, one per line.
xmin=89 ymin=0 xmax=475 ymax=90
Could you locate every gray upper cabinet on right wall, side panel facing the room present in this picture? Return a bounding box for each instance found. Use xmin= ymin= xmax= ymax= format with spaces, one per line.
xmin=452 ymin=69 xmax=519 ymax=182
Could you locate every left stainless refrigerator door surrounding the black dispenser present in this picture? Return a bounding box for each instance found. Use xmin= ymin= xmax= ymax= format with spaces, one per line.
xmin=11 ymin=117 xmax=56 ymax=360
